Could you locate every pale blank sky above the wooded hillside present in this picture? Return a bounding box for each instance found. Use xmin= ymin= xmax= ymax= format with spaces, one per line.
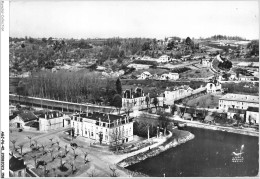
xmin=10 ymin=1 xmax=259 ymax=40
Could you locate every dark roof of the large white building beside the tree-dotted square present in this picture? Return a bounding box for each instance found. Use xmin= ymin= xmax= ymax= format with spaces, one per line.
xmin=75 ymin=112 xmax=131 ymax=122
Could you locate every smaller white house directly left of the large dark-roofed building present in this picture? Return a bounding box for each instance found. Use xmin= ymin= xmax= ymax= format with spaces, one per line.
xmin=35 ymin=110 xmax=70 ymax=131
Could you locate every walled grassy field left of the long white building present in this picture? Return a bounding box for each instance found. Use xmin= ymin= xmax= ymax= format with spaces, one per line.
xmin=187 ymin=94 xmax=221 ymax=108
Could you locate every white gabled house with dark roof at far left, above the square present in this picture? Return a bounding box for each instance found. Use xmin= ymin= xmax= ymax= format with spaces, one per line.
xmin=10 ymin=110 xmax=38 ymax=129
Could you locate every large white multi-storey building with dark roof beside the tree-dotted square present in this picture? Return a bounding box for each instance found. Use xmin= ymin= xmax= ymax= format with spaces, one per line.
xmin=71 ymin=112 xmax=133 ymax=144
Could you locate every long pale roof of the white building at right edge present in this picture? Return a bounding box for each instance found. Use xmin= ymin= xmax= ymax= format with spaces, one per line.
xmin=219 ymin=93 xmax=259 ymax=103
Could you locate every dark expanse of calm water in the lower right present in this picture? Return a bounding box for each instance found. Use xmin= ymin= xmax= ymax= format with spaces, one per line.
xmin=127 ymin=127 xmax=259 ymax=177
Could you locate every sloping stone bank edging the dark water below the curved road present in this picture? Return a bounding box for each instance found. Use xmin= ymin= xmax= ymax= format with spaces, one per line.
xmin=117 ymin=131 xmax=195 ymax=168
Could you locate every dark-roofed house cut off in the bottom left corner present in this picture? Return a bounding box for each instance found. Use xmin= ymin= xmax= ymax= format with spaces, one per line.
xmin=9 ymin=156 xmax=26 ymax=177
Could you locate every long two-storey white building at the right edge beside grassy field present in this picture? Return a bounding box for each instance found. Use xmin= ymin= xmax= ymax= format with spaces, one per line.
xmin=219 ymin=93 xmax=259 ymax=111
